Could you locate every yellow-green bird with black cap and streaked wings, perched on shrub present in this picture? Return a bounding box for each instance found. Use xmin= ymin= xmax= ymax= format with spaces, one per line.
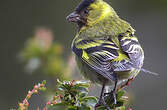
xmin=66 ymin=0 xmax=144 ymax=110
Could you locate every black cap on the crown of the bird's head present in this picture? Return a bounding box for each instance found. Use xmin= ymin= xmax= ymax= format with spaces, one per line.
xmin=75 ymin=0 xmax=95 ymax=12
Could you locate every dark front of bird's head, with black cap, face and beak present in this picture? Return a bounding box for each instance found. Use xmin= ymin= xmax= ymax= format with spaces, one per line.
xmin=66 ymin=0 xmax=95 ymax=25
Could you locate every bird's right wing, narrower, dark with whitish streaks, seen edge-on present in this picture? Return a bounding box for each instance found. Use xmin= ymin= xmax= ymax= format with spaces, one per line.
xmin=118 ymin=31 xmax=144 ymax=69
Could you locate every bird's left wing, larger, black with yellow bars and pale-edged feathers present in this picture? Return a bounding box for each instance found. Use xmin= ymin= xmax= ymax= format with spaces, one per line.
xmin=72 ymin=38 xmax=119 ymax=80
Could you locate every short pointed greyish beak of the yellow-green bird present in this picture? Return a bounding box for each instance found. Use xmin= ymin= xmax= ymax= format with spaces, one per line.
xmin=66 ymin=12 xmax=81 ymax=23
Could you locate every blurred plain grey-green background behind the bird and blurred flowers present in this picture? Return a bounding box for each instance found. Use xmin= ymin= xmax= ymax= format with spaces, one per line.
xmin=0 ymin=0 xmax=167 ymax=110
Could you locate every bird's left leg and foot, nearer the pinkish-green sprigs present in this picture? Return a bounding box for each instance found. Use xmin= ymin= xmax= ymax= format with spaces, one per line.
xmin=95 ymin=83 xmax=110 ymax=110
